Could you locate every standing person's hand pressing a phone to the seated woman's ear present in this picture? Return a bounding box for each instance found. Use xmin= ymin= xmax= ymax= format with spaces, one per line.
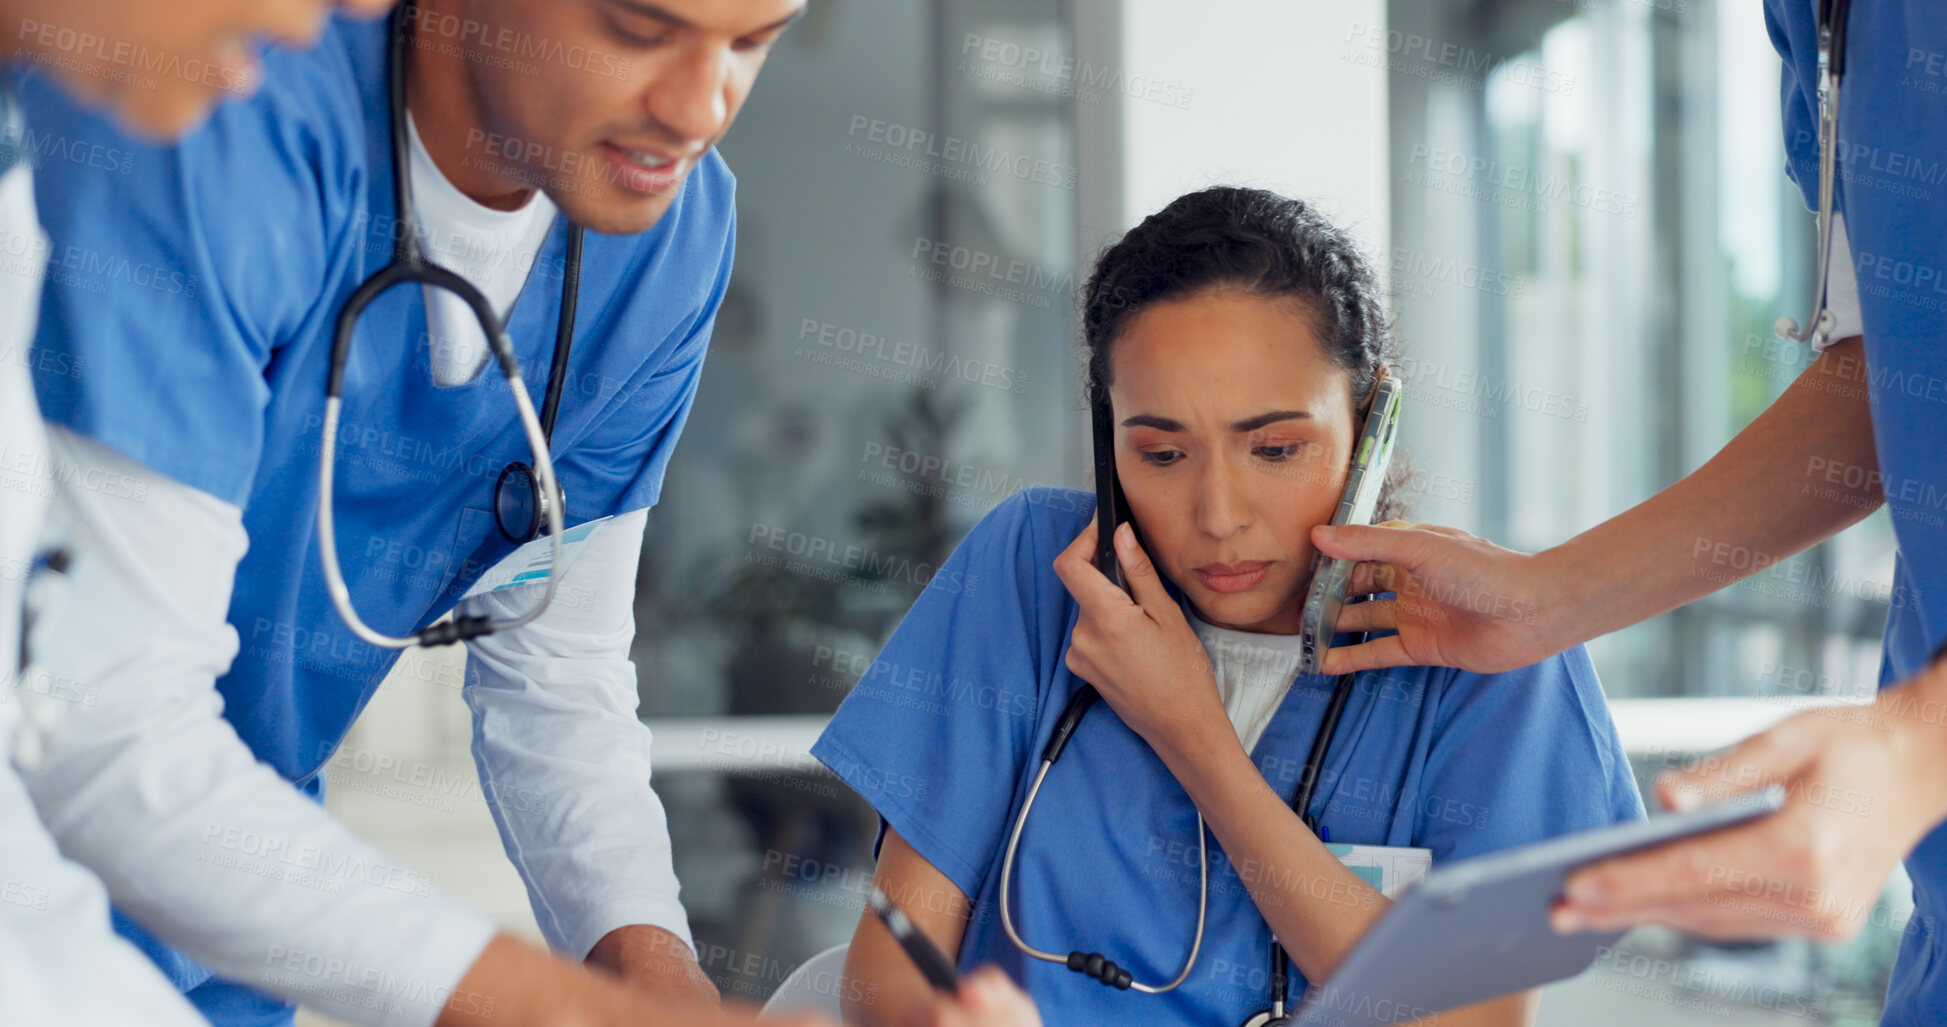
xmin=1312 ymin=520 xmax=1581 ymax=674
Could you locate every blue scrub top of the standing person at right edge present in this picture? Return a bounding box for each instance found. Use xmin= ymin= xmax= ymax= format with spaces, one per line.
xmin=1764 ymin=0 xmax=1947 ymax=1027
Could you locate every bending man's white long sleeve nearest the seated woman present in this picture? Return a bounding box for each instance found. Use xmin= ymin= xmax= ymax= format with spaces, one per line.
xmin=461 ymin=511 xmax=691 ymax=959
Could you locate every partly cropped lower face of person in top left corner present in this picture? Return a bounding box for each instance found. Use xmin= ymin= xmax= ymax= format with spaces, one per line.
xmin=11 ymin=0 xmax=391 ymax=138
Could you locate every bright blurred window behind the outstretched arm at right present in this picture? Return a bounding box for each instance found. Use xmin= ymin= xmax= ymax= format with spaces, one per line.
xmin=1388 ymin=0 xmax=1908 ymax=1023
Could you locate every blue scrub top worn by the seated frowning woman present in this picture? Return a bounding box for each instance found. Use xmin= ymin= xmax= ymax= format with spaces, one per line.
xmin=812 ymin=489 xmax=1643 ymax=1025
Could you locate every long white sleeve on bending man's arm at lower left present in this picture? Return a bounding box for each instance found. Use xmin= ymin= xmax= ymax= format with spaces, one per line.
xmin=23 ymin=429 xmax=495 ymax=1027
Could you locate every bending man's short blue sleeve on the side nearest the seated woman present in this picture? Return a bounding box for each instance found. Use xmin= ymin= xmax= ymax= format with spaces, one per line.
xmin=559 ymin=205 xmax=736 ymax=524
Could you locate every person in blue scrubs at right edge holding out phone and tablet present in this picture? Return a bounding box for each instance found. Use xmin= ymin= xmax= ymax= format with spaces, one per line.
xmin=1314 ymin=0 xmax=1947 ymax=1027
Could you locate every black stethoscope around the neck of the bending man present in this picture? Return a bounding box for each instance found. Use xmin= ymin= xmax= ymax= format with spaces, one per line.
xmin=317 ymin=4 xmax=582 ymax=649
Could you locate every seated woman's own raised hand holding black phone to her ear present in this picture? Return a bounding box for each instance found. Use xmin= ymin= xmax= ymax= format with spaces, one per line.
xmin=1055 ymin=520 xmax=1236 ymax=760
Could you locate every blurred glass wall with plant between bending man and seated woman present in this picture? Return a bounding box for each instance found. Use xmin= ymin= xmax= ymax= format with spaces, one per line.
xmin=635 ymin=0 xmax=1083 ymax=998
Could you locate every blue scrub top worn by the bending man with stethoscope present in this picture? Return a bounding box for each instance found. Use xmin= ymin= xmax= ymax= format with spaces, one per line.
xmin=21 ymin=19 xmax=734 ymax=1021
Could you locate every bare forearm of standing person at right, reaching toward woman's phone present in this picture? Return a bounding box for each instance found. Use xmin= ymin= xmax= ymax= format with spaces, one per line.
xmin=1540 ymin=339 xmax=1883 ymax=649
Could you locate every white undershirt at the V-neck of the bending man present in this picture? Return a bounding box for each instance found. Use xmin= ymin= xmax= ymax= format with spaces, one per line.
xmin=407 ymin=117 xmax=557 ymax=386
